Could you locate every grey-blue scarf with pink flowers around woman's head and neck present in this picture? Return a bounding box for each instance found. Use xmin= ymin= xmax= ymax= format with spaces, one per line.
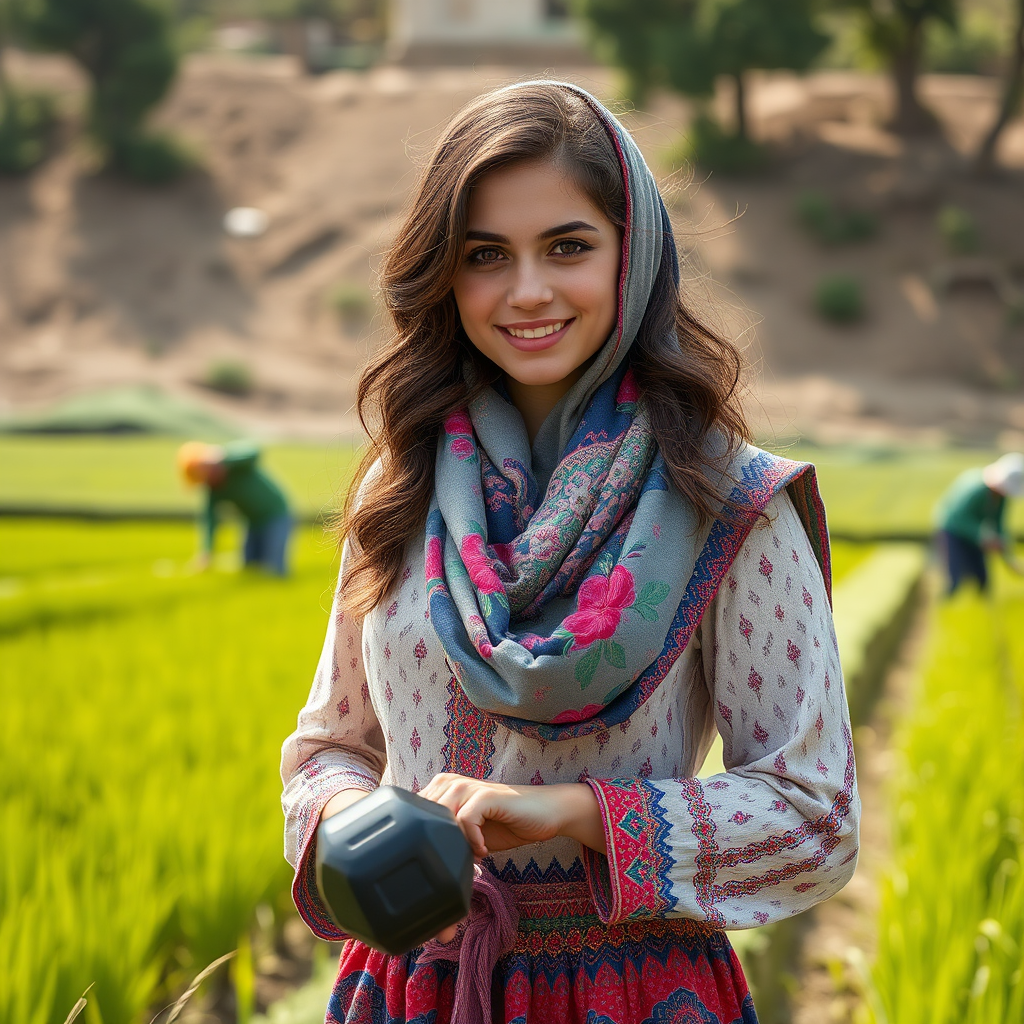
xmin=426 ymin=83 xmax=827 ymax=739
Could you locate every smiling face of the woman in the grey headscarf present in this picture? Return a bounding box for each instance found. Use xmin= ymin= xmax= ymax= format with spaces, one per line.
xmin=454 ymin=161 xmax=622 ymax=435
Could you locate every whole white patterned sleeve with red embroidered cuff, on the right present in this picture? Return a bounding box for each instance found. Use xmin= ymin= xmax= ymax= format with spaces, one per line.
xmin=585 ymin=494 xmax=860 ymax=928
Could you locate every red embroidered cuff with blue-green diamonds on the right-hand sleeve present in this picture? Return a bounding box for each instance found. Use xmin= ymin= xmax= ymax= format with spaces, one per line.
xmin=584 ymin=778 xmax=676 ymax=925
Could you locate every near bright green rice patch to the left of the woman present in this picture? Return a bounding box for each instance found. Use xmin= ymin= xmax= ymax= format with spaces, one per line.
xmin=0 ymin=523 xmax=342 ymax=1024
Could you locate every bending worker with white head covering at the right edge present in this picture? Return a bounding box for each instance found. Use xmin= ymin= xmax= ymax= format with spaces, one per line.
xmin=935 ymin=452 xmax=1024 ymax=594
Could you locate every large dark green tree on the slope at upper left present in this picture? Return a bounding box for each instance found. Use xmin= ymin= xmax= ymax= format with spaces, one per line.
xmin=26 ymin=0 xmax=183 ymax=180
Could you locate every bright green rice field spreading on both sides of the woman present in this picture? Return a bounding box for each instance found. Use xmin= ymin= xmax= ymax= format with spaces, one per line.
xmin=0 ymin=437 xmax=1024 ymax=1024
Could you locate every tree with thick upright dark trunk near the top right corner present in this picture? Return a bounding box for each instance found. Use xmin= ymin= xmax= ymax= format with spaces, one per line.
xmin=840 ymin=0 xmax=957 ymax=135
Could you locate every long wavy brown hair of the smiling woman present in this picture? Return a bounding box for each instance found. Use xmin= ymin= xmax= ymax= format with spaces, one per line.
xmin=336 ymin=83 xmax=749 ymax=614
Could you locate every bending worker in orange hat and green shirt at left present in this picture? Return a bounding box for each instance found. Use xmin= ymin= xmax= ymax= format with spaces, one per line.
xmin=178 ymin=441 xmax=292 ymax=575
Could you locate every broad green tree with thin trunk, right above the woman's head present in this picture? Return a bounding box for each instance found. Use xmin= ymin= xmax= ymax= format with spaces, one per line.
xmin=583 ymin=0 xmax=828 ymax=140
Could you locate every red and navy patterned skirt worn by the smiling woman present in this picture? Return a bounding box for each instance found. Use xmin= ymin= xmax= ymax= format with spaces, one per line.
xmin=327 ymin=872 xmax=757 ymax=1024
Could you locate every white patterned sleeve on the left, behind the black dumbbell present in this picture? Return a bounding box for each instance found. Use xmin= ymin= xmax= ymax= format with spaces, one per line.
xmin=281 ymin=557 xmax=386 ymax=939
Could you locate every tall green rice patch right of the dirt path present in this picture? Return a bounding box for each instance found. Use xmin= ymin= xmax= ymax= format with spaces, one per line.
xmin=867 ymin=579 xmax=1024 ymax=1024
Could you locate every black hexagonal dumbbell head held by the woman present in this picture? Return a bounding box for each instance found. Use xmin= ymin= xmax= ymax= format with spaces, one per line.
xmin=316 ymin=785 xmax=473 ymax=956
